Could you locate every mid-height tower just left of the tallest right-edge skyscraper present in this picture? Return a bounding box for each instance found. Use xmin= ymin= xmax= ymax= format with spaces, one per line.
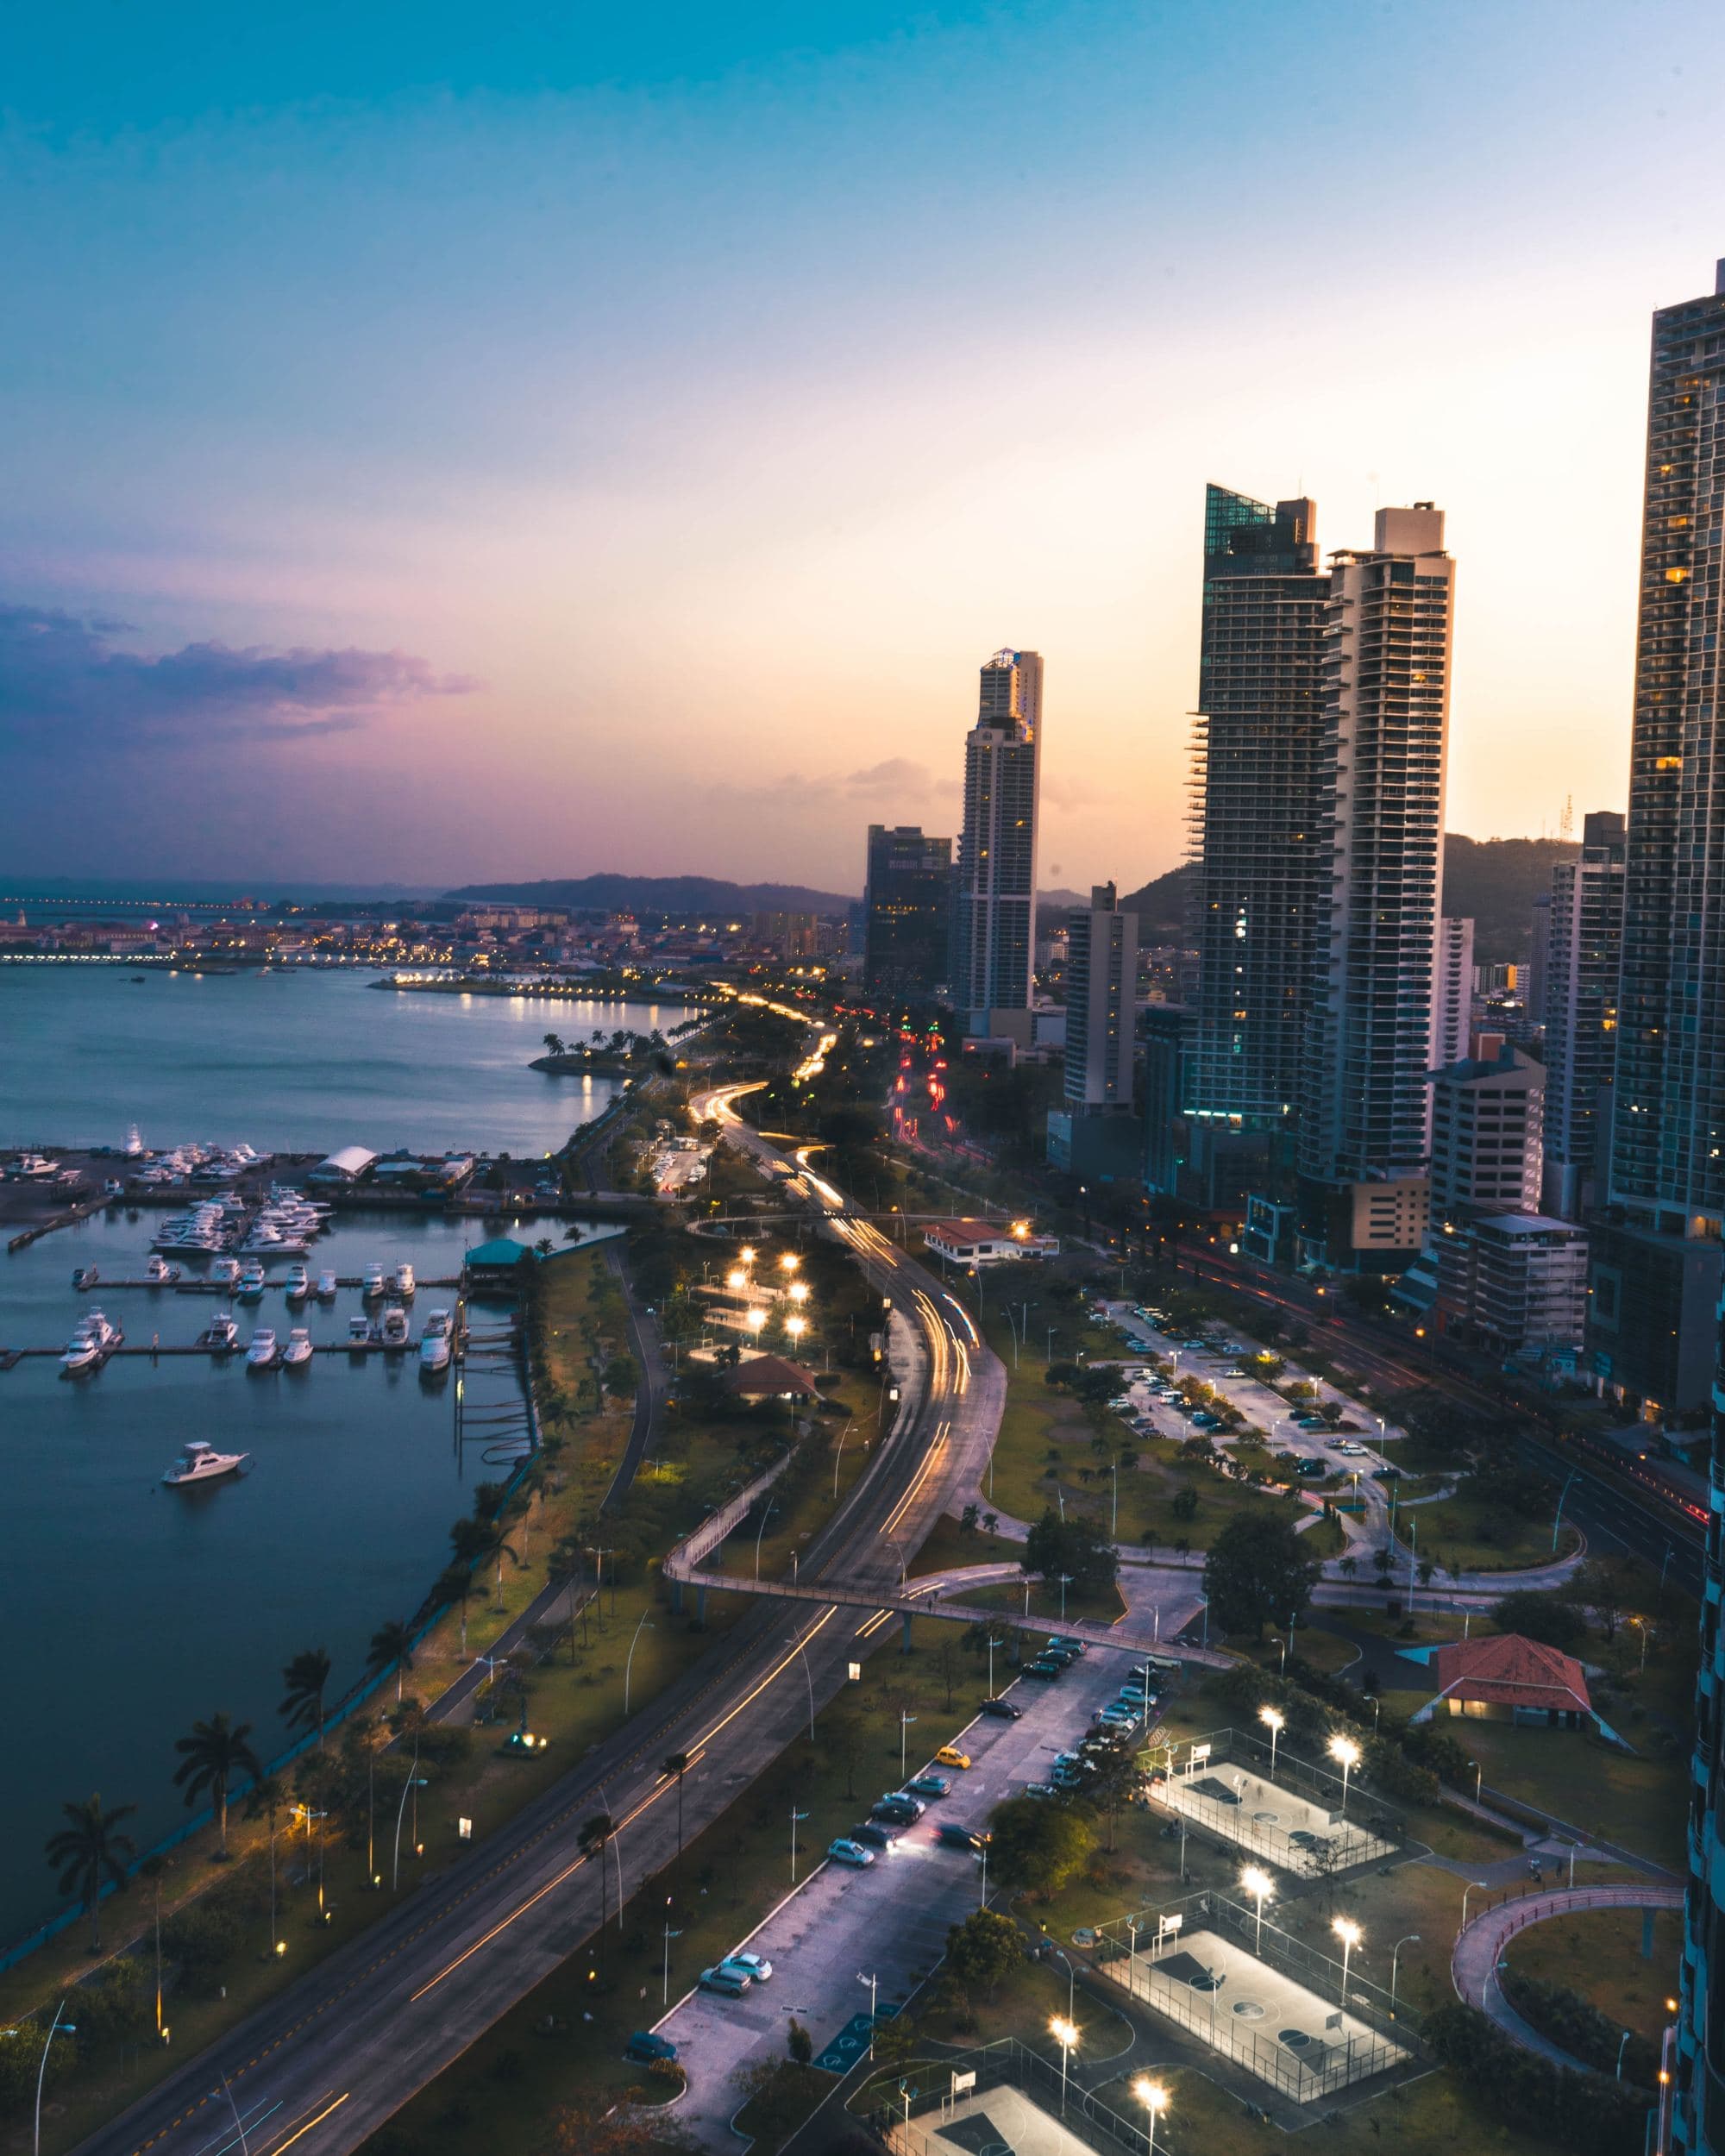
xmin=1542 ymin=809 xmax=1624 ymax=1220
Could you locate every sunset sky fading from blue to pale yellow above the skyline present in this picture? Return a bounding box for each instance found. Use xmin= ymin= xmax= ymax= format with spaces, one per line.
xmin=0 ymin=0 xmax=1725 ymax=891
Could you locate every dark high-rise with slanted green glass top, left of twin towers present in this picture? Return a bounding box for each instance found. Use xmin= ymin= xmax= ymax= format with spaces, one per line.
xmin=1184 ymin=486 xmax=1331 ymax=1134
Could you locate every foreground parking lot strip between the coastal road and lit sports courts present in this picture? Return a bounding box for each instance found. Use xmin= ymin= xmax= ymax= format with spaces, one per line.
xmin=656 ymin=1647 xmax=1164 ymax=2150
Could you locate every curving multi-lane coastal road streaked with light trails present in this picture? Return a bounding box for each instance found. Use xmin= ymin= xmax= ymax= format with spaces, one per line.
xmin=82 ymin=1095 xmax=1005 ymax=2156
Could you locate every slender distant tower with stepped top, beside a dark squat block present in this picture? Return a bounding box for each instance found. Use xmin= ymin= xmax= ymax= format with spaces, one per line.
xmin=951 ymin=651 xmax=1042 ymax=1039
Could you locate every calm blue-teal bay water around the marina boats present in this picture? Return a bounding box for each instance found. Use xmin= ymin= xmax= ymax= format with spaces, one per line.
xmin=0 ymin=966 xmax=660 ymax=1949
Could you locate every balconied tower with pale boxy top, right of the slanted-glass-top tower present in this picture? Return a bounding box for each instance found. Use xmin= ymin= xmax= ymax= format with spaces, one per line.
xmin=1298 ymin=503 xmax=1456 ymax=1263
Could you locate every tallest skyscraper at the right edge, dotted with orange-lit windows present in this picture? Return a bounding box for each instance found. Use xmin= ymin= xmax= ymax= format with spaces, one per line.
xmin=1590 ymin=263 xmax=1725 ymax=1414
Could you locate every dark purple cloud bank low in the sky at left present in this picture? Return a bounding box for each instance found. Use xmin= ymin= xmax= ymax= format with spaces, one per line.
xmin=0 ymin=606 xmax=479 ymax=744
